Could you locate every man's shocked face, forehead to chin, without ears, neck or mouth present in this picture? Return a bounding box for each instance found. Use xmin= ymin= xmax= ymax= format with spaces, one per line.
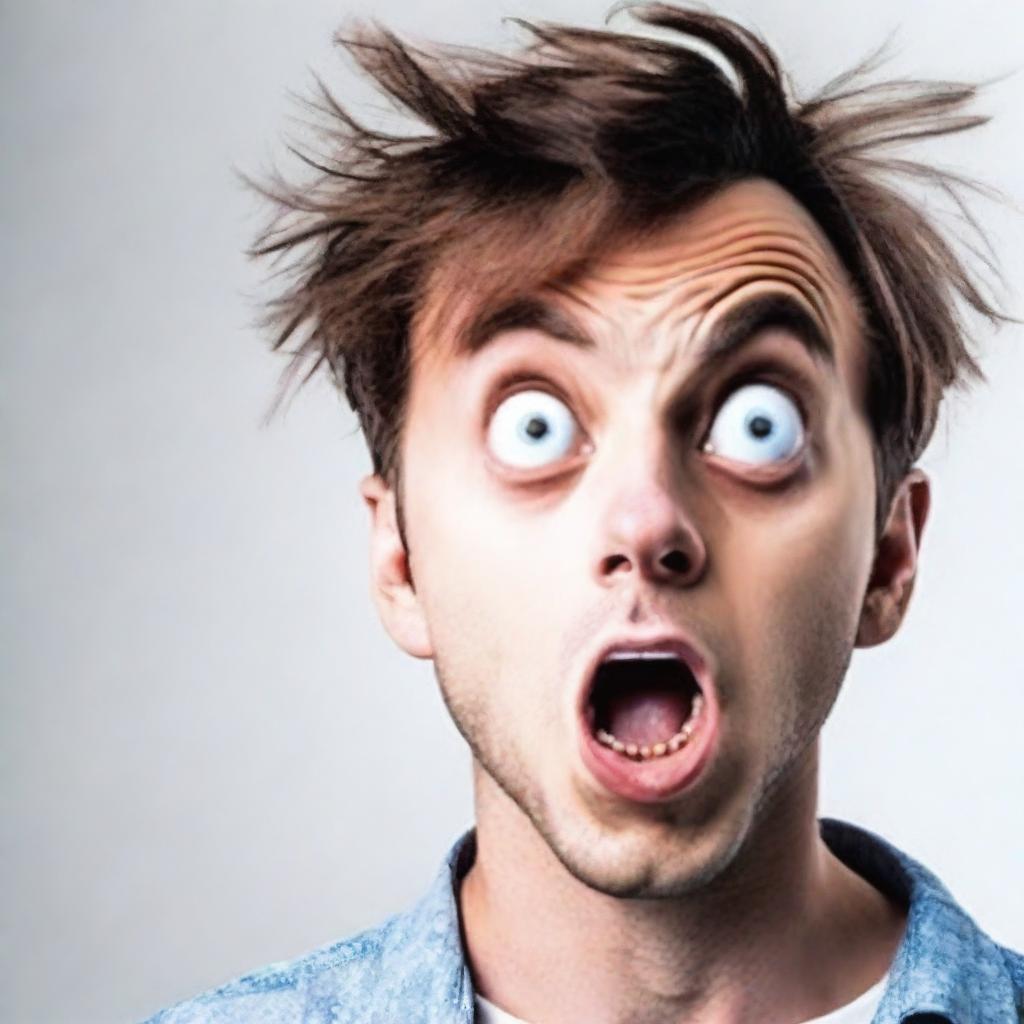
xmin=387 ymin=180 xmax=874 ymax=896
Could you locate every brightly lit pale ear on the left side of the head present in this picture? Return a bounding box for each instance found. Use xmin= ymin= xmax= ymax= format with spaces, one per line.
xmin=359 ymin=473 xmax=433 ymax=657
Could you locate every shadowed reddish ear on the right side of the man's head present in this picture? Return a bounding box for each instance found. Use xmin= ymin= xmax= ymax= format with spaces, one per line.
xmin=856 ymin=469 xmax=932 ymax=647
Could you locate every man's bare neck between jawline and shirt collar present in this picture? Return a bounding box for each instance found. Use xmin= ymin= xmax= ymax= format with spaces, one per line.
xmin=459 ymin=743 xmax=904 ymax=1024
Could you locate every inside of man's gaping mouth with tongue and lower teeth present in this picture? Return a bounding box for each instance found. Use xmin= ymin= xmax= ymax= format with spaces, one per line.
xmin=587 ymin=651 xmax=705 ymax=761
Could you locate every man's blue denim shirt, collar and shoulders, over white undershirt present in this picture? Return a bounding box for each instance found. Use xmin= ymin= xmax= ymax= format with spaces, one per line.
xmin=146 ymin=818 xmax=1024 ymax=1024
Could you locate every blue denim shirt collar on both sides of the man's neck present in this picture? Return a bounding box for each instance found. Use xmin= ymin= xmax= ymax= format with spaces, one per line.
xmin=386 ymin=818 xmax=1019 ymax=1024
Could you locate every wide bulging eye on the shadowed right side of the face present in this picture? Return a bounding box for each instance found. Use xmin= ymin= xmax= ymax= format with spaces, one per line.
xmin=705 ymin=384 xmax=804 ymax=466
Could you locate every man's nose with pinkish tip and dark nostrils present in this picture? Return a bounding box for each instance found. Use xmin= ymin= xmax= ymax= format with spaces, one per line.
xmin=595 ymin=436 xmax=708 ymax=587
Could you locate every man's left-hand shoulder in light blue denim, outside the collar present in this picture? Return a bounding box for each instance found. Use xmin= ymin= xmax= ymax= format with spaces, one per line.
xmin=137 ymin=914 xmax=402 ymax=1024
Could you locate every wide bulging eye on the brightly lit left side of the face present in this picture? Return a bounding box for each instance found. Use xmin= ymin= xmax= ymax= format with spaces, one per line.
xmin=487 ymin=390 xmax=577 ymax=469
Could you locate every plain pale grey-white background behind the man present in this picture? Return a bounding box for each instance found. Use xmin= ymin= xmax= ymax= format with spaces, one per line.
xmin=0 ymin=0 xmax=1024 ymax=1022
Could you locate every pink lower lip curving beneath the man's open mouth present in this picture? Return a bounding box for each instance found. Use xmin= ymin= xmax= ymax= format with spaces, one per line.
xmin=580 ymin=688 xmax=718 ymax=804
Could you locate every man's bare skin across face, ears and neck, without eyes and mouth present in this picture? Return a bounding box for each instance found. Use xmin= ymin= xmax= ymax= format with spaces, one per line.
xmin=361 ymin=180 xmax=929 ymax=1024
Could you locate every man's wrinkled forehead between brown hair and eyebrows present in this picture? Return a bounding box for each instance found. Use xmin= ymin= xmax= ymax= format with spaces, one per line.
xmin=420 ymin=179 xmax=861 ymax=385
